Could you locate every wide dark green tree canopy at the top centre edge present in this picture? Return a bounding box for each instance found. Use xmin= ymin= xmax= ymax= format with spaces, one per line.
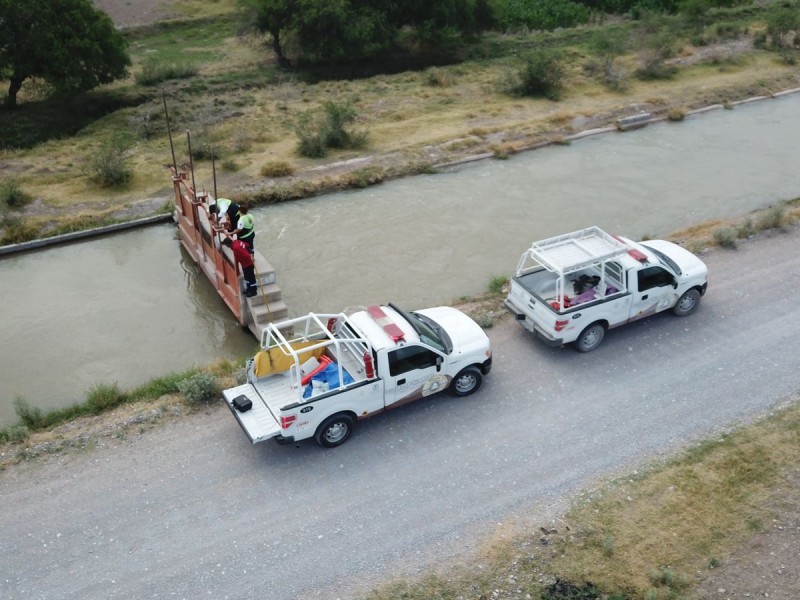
xmin=241 ymin=0 xmax=490 ymax=66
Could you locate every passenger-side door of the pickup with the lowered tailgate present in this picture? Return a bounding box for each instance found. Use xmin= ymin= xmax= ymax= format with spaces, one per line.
xmin=384 ymin=344 xmax=447 ymax=408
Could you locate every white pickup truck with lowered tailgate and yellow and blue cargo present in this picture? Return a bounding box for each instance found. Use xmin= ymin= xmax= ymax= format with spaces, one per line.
xmin=222 ymin=304 xmax=492 ymax=447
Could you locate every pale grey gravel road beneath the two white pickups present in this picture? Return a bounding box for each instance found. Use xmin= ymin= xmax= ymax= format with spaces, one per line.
xmin=0 ymin=227 xmax=800 ymax=600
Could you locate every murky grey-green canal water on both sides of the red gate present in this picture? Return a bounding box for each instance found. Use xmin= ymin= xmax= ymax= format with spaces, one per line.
xmin=0 ymin=94 xmax=800 ymax=426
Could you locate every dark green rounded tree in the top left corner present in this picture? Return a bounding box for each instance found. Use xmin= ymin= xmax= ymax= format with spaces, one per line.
xmin=0 ymin=0 xmax=131 ymax=108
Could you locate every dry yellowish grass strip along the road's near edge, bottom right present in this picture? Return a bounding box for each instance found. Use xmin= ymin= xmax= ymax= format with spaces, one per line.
xmin=364 ymin=398 xmax=800 ymax=600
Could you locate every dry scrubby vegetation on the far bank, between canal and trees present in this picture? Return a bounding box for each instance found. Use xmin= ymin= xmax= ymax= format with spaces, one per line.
xmin=0 ymin=0 xmax=800 ymax=240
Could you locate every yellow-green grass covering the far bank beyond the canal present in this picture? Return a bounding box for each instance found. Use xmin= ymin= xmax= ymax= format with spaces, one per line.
xmin=0 ymin=0 xmax=794 ymax=237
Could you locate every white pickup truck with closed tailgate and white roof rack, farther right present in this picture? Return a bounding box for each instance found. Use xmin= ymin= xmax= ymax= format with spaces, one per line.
xmin=505 ymin=227 xmax=708 ymax=352
